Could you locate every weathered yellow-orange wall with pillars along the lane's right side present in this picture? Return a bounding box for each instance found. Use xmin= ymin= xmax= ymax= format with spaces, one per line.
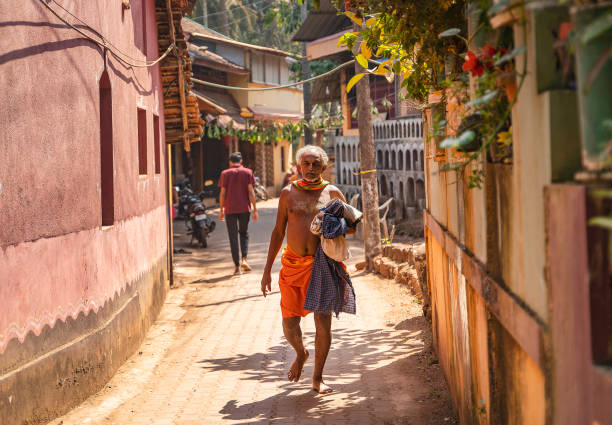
xmin=424 ymin=3 xmax=612 ymax=425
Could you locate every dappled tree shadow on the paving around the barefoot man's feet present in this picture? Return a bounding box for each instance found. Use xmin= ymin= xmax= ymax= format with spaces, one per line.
xmin=199 ymin=318 xmax=455 ymax=425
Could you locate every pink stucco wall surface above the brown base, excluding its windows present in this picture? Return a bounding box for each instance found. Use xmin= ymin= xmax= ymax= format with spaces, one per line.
xmin=0 ymin=0 xmax=168 ymax=354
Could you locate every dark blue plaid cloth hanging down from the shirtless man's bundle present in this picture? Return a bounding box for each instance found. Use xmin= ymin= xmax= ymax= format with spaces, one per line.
xmin=304 ymin=245 xmax=356 ymax=317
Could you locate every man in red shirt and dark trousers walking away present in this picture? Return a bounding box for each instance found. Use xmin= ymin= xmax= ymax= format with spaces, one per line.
xmin=219 ymin=152 xmax=258 ymax=274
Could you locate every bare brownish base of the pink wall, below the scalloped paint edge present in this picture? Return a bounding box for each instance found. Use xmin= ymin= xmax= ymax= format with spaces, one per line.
xmin=0 ymin=255 xmax=168 ymax=425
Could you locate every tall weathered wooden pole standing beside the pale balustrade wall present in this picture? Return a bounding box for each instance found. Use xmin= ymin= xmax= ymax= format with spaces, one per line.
xmin=355 ymin=43 xmax=381 ymax=270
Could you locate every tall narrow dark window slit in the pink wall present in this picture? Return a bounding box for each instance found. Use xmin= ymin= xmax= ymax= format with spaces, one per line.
xmin=99 ymin=71 xmax=115 ymax=226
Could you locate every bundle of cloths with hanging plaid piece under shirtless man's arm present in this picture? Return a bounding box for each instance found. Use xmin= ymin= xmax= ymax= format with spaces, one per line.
xmin=304 ymin=198 xmax=363 ymax=316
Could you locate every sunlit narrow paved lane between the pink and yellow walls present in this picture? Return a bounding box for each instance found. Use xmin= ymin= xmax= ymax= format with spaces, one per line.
xmin=51 ymin=199 xmax=457 ymax=425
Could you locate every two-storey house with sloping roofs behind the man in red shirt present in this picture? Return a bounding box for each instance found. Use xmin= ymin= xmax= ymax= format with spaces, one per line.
xmin=175 ymin=18 xmax=303 ymax=195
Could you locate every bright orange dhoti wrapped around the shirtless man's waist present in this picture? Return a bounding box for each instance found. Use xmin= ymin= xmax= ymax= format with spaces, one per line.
xmin=278 ymin=245 xmax=314 ymax=318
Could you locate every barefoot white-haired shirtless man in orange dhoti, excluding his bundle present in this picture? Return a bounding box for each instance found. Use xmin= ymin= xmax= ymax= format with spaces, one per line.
xmin=261 ymin=145 xmax=352 ymax=394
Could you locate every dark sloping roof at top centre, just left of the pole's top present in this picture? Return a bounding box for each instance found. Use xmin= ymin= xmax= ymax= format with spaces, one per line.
xmin=291 ymin=0 xmax=352 ymax=42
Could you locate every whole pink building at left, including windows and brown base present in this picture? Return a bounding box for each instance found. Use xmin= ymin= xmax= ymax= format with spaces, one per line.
xmin=0 ymin=0 xmax=194 ymax=425
